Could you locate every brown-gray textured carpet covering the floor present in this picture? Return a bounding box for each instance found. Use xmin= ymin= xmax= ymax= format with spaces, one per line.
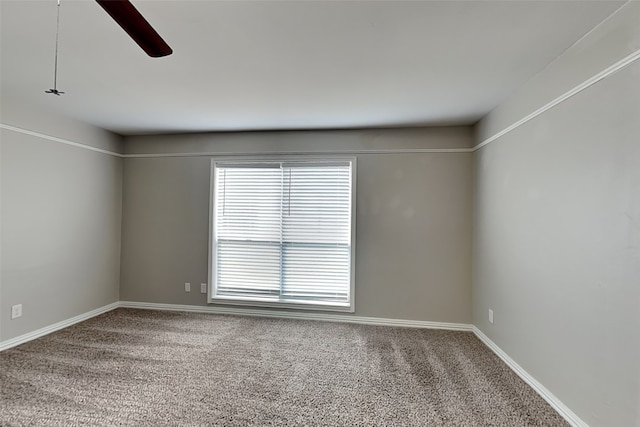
xmin=0 ymin=309 xmax=568 ymax=427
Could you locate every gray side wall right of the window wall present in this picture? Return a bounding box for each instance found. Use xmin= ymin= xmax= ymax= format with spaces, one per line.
xmin=473 ymin=3 xmax=640 ymax=427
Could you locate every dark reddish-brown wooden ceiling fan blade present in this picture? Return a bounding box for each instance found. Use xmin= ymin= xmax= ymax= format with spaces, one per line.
xmin=96 ymin=0 xmax=173 ymax=58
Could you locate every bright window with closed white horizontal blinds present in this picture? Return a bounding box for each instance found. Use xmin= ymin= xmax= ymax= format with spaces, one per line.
xmin=209 ymin=159 xmax=354 ymax=311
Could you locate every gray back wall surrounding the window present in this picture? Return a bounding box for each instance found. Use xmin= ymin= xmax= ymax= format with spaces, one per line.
xmin=120 ymin=128 xmax=472 ymax=323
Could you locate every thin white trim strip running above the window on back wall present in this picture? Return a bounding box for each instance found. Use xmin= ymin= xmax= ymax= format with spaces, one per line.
xmin=122 ymin=148 xmax=473 ymax=159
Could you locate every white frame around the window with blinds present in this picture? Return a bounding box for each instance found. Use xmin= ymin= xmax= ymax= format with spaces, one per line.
xmin=207 ymin=154 xmax=357 ymax=313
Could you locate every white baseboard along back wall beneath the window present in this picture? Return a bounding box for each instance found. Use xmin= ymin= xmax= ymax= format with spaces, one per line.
xmin=120 ymin=301 xmax=473 ymax=332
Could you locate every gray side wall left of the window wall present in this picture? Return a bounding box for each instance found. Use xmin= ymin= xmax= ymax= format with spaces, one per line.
xmin=0 ymin=98 xmax=122 ymax=341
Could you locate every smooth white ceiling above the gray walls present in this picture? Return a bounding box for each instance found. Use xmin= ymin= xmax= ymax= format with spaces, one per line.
xmin=0 ymin=0 xmax=624 ymax=134
